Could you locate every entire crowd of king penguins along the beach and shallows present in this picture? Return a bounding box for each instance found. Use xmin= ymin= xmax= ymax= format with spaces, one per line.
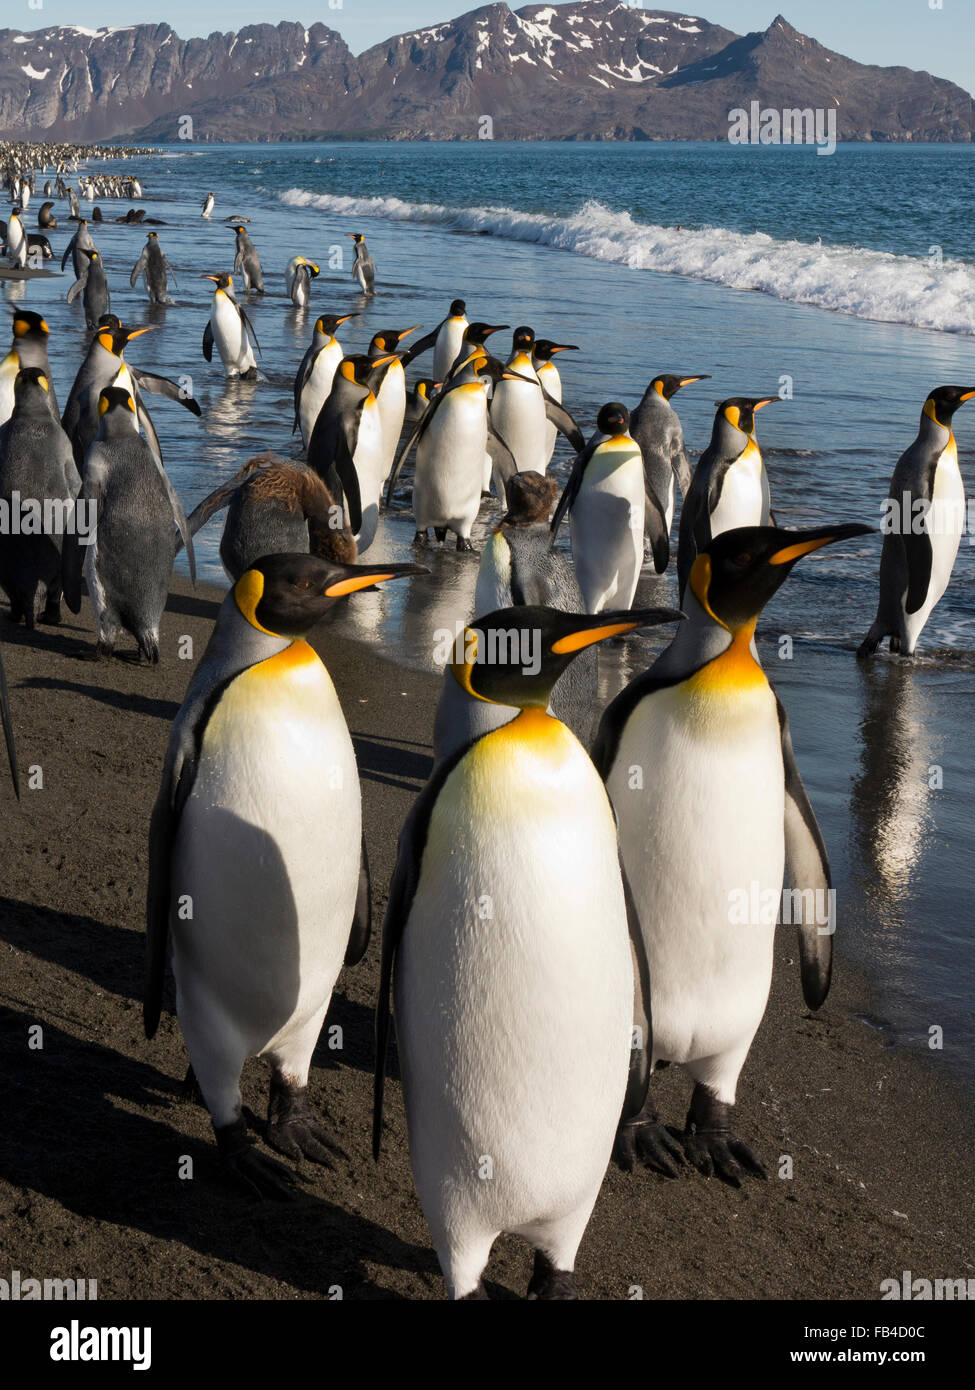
xmin=0 ymin=147 xmax=975 ymax=1300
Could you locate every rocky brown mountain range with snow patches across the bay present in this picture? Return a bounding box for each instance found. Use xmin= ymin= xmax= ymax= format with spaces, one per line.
xmin=0 ymin=0 xmax=975 ymax=140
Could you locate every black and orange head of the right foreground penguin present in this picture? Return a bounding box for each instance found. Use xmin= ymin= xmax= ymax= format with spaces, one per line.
xmin=687 ymin=521 xmax=875 ymax=632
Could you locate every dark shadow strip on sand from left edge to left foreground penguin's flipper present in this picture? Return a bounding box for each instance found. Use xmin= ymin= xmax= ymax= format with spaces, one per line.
xmin=0 ymin=898 xmax=145 ymax=1001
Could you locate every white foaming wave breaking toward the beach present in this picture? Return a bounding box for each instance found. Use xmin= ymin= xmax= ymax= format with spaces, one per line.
xmin=280 ymin=188 xmax=975 ymax=334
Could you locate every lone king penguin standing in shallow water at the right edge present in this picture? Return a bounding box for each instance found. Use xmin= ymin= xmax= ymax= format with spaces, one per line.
xmin=857 ymin=386 xmax=975 ymax=657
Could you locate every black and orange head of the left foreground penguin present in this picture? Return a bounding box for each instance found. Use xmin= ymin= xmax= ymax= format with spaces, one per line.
xmin=234 ymin=553 xmax=430 ymax=638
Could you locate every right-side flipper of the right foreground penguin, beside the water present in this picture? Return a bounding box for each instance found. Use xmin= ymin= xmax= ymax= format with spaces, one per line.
xmin=775 ymin=695 xmax=835 ymax=1009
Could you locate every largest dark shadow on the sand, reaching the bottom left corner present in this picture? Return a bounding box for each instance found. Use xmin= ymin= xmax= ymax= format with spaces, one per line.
xmin=0 ymin=1005 xmax=437 ymax=1298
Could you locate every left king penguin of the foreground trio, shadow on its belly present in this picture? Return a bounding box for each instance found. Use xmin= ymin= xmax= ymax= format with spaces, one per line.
xmin=143 ymin=555 xmax=417 ymax=1195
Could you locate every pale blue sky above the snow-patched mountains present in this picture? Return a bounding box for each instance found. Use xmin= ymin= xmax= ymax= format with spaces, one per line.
xmin=13 ymin=0 xmax=975 ymax=92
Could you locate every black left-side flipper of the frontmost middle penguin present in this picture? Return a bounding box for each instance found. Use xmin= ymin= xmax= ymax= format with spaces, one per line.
xmin=373 ymin=739 xmax=476 ymax=1162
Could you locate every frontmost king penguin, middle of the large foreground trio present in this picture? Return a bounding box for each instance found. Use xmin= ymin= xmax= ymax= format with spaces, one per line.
xmin=373 ymin=607 xmax=680 ymax=1300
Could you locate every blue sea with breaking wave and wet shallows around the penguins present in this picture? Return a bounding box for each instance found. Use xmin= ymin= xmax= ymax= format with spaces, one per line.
xmin=0 ymin=142 xmax=975 ymax=1069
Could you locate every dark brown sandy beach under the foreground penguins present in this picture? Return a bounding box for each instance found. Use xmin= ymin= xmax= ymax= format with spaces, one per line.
xmin=0 ymin=581 xmax=975 ymax=1298
